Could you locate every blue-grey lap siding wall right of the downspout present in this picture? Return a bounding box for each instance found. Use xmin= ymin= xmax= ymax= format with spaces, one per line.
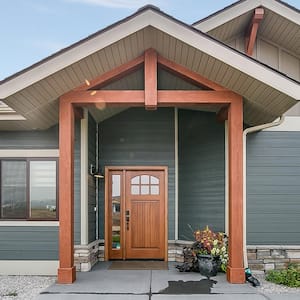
xmin=247 ymin=131 xmax=300 ymax=245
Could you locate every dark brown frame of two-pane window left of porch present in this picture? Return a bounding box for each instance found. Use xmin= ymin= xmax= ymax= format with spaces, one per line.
xmin=0 ymin=157 xmax=59 ymax=222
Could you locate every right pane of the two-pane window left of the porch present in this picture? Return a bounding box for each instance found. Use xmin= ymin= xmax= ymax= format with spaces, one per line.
xmin=29 ymin=161 xmax=56 ymax=219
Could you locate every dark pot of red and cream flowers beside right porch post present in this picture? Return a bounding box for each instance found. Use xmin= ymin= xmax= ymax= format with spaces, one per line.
xmin=192 ymin=226 xmax=228 ymax=278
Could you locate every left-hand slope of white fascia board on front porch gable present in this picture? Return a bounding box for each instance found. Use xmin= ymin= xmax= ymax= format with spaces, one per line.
xmin=0 ymin=11 xmax=151 ymax=99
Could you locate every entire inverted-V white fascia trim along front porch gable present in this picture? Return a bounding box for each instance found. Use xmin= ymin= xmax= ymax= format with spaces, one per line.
xmin=0 ymin=8 xmax=300 ymax=100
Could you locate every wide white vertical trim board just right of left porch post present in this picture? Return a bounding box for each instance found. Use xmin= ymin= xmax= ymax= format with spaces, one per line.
xmin=80 ymin=108 xmax=89 ymax=245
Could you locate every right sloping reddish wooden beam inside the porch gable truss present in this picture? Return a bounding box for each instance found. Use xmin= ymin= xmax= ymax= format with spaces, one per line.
xmin=157 ymin=55 xmax=228 ymax=91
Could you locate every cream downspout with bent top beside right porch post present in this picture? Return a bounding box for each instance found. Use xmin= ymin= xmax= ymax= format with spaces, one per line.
xmin=243 ymin=115 xmax=284 ymax=269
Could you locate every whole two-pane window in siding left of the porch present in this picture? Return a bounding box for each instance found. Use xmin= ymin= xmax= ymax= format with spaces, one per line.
xmin=0 ymin=158 xmax=58 ymax=220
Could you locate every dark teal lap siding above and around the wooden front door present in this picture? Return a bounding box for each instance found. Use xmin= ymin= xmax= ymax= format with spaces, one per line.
xmin=99 ymin=108 xmax=175 ymax=239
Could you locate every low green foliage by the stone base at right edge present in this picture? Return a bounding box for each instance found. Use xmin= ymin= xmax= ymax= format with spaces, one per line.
xmin=266 ymin=264 xmax=300 ymax=287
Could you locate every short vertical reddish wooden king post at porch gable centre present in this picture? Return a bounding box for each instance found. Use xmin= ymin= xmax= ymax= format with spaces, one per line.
xmin=145 ymin=49 xmax=157 ymax=110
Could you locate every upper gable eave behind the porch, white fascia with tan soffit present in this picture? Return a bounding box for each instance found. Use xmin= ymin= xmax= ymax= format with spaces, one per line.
xmin=193 ymin=0 xmax=300 ymax=55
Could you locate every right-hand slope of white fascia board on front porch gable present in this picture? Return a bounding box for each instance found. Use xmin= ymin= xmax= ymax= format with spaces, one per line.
xmin=151 ymin=14 xmax=300 ymax=100
